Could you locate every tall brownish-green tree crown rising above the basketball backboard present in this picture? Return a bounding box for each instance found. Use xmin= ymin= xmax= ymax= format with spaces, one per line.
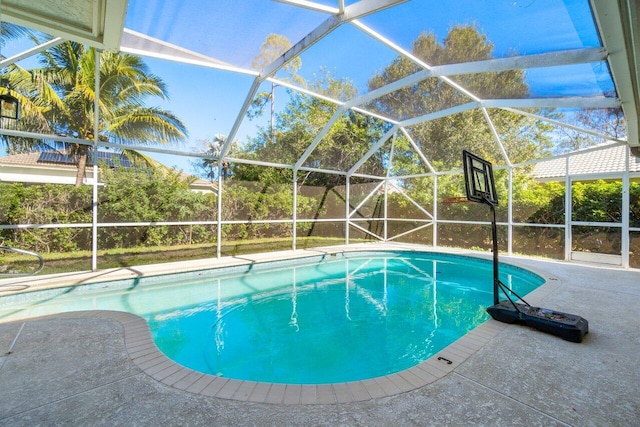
xmin=369 ymin=25 xmax=546 ymax=169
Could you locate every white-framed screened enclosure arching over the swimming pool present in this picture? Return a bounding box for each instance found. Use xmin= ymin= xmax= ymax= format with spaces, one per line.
xmin=0 ymin=0 xmax=640 ymax=272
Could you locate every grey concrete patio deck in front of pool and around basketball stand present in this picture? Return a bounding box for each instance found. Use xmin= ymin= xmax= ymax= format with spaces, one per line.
xmin=0 ymin=249 xmax=640 ymax=426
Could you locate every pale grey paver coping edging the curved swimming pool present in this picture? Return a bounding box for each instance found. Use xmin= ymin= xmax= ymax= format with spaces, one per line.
xmin=0 ymin=245 xmax=560 ymax=405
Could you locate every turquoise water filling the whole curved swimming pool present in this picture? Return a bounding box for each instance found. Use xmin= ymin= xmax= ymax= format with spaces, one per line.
xmin=0 ymin=252 xmax=544 ymax=384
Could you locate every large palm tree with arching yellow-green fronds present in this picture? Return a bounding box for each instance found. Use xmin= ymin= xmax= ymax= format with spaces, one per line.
xmin=10 ymin=41 xmax=187 ymax=187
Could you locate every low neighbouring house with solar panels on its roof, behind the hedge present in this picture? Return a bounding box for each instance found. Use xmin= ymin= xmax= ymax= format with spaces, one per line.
xmin=0 ymin=151 xmax=217 ymax=193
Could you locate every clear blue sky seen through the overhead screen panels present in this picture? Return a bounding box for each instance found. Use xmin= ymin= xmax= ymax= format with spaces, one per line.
xmin=1 ymin=0 xmax=611 ymax=172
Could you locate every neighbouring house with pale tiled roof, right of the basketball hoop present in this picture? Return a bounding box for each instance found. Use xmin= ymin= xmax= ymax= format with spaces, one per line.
xmin=533 ymin=142 xmax=640 ymax=182
